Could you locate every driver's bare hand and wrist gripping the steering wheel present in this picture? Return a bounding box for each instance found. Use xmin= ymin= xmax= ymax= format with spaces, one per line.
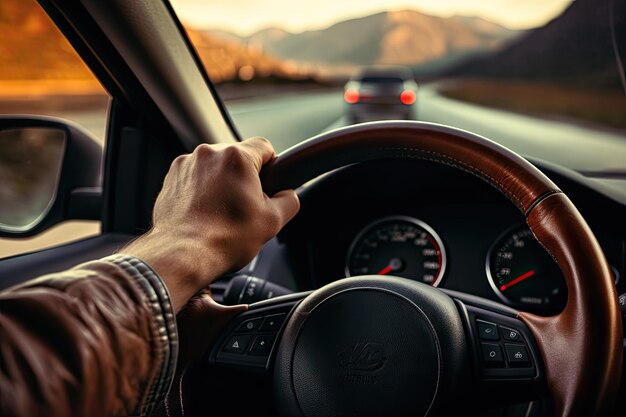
xmin=122 ymin=138 xmax=300 ymax=312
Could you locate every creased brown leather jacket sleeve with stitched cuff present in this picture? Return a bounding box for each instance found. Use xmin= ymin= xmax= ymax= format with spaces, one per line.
xmin=0 ymin=255 xmax=178 ymax=417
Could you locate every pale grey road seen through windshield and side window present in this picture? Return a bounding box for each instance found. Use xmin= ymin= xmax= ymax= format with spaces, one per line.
xmin=0 ymin=86 xmax=626 ymax=257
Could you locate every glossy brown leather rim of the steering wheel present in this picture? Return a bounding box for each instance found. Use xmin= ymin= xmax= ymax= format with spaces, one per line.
xmin=261 ymin=121 xmax=623 ymax=416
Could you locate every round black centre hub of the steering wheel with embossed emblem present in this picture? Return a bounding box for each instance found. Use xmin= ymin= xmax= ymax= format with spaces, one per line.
xmin=275 ymin=278 xmax=464 ymax=416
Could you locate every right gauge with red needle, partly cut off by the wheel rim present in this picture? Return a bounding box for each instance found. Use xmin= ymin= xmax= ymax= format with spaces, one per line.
xmin=487 ymin=226 xmax=567 ymax=309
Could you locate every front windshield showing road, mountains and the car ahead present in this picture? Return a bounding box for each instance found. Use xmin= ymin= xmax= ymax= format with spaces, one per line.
xmin=172 ymin=0 xmax=626 ymax=178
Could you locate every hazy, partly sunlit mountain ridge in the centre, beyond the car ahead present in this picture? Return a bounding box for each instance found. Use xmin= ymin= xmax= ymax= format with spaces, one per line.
xmin=210 ymin=10 xmax=519 ymax=65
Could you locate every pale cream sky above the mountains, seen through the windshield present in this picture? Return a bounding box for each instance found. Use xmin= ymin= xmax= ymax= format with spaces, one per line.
xmin=170 ymin=0 xmax=575 ymax=35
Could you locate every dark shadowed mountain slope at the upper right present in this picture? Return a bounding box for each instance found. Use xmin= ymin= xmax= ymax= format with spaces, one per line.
xmin=448 ymin=0 xmax=626 ymax=88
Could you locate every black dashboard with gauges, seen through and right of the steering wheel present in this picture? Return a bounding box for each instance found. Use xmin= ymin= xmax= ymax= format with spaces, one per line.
xmin=253 ymin=159 xmax=626 ymax=315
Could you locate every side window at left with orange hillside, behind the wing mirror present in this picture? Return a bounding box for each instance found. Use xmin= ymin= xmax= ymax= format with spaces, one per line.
xmin=0 ymin=0 xmax=109 ymax=258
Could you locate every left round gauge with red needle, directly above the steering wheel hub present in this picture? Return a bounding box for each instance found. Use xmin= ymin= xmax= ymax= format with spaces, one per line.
xmin=346 ymin=216 xmax=446 ymax=286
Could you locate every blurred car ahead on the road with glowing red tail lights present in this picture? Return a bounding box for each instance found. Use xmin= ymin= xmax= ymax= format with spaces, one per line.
xmin=343 ymin=65 xmax=417 ymax=123
